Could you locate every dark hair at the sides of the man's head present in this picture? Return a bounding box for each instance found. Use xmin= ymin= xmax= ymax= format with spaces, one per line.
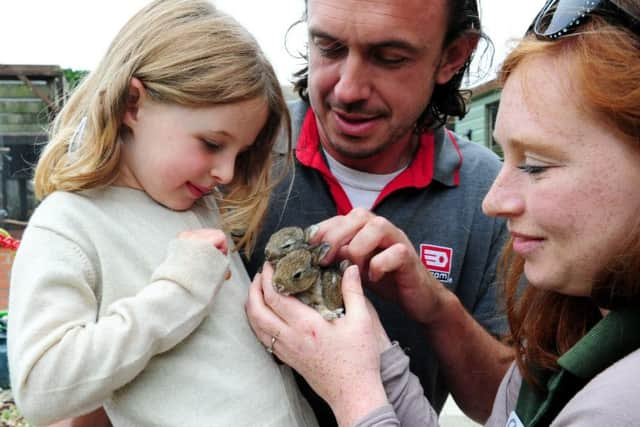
xmin=290 ymin=0 xmax=491 ymax=132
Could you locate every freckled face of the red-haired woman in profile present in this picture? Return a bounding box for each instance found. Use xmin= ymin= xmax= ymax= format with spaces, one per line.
xmin=482 ymin=56 xmax=640 ymax=296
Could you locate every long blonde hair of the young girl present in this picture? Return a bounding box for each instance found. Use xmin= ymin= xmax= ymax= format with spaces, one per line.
xmin=34 ymin=0 xmax=291 ymax=252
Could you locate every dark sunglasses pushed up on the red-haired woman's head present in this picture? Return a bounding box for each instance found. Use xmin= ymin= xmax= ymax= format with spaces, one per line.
xmin=527 ymin=0 xmax=640 ymax=40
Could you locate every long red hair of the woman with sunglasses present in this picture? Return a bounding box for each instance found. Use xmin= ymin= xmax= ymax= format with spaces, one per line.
xmin=500 ymin=13 xmax=640 ymax=386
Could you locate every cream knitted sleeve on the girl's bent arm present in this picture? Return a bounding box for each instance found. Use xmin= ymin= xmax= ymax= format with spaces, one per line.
xmin=8 ymin=227 xmax=229 ymax=424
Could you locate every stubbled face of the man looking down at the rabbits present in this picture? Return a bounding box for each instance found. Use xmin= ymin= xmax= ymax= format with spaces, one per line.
xmin=308 ymin=0 xmax=455 ymax=173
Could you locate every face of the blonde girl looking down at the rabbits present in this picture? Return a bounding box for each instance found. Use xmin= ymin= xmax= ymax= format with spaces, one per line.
xmin=116 ymin=83 xmax=267 ymax=211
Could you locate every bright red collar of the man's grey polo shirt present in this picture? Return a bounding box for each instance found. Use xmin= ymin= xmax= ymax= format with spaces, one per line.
xmin=296 ymin=108 xmax=462 ymax=215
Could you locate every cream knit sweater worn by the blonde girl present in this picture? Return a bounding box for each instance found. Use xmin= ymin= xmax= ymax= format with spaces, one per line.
xmin=8 ymin=187 xmax=315 ymax=426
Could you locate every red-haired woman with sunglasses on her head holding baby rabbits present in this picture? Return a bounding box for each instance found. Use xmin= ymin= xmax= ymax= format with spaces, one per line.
xmin=247 ymin=0 xmax=640 ymax=426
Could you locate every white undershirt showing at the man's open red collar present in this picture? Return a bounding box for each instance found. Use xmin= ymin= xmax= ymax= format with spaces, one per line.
xmin=322 ymin=149 xmax=407 ymax=209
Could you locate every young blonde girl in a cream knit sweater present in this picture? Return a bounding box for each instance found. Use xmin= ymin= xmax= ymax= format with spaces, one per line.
xmin=9 ymin=0 xmax=315 ymax=426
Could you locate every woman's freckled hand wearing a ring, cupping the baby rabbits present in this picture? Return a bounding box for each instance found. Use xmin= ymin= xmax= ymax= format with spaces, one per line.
xmin=245 ymin=263 xmax=391 ymax=425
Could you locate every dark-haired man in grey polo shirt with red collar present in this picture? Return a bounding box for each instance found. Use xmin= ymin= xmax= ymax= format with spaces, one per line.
xmin=247 ymin=0 xmax=511 ymax=426
